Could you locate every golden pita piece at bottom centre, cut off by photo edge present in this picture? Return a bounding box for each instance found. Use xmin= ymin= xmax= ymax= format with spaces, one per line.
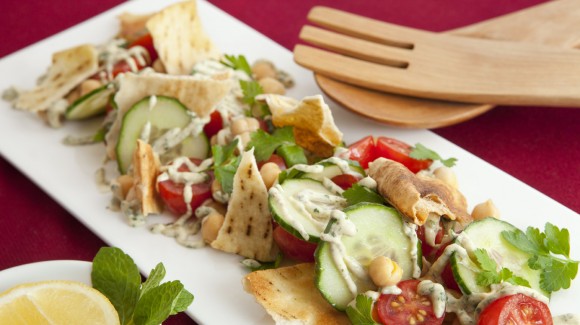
xmin=243 ymin=263 xmax=350 ymax=325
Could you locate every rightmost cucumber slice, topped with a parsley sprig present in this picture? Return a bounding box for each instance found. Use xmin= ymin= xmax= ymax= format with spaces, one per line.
xmin=449 ymin=217 xmax=549 ymax=297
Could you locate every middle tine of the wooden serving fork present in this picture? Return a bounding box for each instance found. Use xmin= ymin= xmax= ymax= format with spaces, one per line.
xmin=299 ymin=26 xmax=411 ymax=68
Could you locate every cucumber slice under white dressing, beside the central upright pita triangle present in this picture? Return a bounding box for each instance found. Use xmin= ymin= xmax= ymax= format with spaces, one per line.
xmin=268 ymin=178 xmax=346 ymax=243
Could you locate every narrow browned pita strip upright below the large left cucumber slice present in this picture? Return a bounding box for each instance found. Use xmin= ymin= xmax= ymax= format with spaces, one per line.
xmin=133 ymin=140 xmax=163 ymax=216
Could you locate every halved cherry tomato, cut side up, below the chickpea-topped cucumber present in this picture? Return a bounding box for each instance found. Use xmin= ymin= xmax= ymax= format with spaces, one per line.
xmin=375 ymin=279 xmax=445 ymax=325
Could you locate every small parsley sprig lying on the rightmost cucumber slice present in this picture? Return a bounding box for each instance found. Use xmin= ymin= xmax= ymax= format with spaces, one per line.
xmin=473 ymin=248 xmax=530 ymax=288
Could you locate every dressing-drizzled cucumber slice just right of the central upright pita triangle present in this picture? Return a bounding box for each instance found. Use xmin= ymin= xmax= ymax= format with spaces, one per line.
xmin=268 ymin=178 xmax=346 ymax=243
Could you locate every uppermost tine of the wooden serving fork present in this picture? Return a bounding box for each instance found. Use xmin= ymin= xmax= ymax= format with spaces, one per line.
xmin=308 ymin=6 xmax=430 ymax=49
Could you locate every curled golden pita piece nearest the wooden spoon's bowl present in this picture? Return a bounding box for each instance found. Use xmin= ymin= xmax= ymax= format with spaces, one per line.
xmin=256 ymin=94 xmax=342 ymax=157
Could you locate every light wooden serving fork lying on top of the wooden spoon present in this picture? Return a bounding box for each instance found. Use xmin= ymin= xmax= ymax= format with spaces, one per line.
xmin=294 ymin=7 xmax=580 ymax=107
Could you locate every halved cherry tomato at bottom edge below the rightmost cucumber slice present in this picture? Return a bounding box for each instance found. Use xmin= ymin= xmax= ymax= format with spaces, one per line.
xmin=477 ymin=293 xmax=553 ymax=325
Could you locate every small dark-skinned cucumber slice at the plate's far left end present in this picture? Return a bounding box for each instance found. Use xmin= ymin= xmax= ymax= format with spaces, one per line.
xmin=64 ymin=84 xmax=115 ymax=120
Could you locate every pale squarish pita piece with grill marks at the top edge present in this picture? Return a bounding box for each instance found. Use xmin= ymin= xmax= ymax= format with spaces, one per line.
xmin=147 ymin=1 xmax=221 ymax=74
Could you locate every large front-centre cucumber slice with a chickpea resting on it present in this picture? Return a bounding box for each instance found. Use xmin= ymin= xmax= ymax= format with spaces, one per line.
xmin=315 ymin=203 xmax=421 ymax=311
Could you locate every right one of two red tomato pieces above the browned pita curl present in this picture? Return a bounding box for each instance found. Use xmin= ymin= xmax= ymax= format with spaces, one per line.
xmin=376 ymin=137 xmax=433 ymax=173
